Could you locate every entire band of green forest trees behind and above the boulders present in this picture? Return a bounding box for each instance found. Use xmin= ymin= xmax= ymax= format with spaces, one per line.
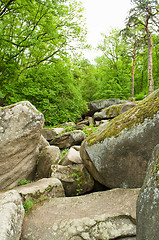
xmin=0 ymin=0 xmax=159 ymax=125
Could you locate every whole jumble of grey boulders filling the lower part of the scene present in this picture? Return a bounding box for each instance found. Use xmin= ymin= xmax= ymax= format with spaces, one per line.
xmin=0 ymin=90 xmax=159 ymax=240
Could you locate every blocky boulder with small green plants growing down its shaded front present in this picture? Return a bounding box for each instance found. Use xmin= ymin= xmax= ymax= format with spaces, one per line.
xmin=51 ymin=164 xmax=94 ymax=197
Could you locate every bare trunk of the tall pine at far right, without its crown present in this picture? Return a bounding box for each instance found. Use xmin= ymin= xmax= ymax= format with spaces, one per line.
xmin=145 ymin=18 xmax=154 ymax=94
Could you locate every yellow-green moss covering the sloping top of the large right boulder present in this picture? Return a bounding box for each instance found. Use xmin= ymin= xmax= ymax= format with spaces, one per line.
xmin=87 ymin=90 xmax=159 ymax=146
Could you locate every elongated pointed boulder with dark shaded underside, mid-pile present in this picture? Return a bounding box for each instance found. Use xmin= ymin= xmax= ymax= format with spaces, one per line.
xmin=50 ymin=130 xmax=85 ymax=149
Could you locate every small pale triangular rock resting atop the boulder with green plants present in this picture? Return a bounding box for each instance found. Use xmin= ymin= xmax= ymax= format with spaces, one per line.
xmin=59 ymin=147 xmax=83 ymax=166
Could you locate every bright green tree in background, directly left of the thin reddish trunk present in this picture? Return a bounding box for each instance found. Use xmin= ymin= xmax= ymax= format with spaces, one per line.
xmin=95 ymin=29 xmax=131 ymax=99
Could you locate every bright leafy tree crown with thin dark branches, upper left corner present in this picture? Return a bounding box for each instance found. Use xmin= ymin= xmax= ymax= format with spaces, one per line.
xmin=0 ymin=0 xmax=85 ymax=80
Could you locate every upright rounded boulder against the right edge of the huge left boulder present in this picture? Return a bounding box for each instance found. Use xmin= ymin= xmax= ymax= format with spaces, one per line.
xmin=36 ymin=146 xmax=61 ymax=179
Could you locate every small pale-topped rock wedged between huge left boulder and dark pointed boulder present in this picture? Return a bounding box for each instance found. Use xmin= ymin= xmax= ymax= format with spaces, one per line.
xmin=42 ymin=128 xmax=65 ymax=141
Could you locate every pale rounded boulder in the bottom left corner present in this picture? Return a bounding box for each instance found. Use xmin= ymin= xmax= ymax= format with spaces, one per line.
xmin=0 ymin=190 xmax=24 ymax=240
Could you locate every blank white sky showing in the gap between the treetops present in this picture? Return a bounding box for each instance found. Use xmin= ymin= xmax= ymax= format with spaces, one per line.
xmin=81 ymin=0 xmax=132 ymax=60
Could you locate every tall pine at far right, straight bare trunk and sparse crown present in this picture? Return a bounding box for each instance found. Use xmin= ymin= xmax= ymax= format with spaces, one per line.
xmin=127 ymin=0 xmax=159 ymax=94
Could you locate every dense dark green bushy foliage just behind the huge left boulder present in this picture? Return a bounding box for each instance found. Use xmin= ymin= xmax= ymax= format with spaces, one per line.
xmin=2 ymin=60 xmax=86 ymax=125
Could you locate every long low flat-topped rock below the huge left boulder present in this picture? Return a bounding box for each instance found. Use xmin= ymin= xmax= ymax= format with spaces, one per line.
xmin=15 ymin=178 xmax=65 ymax=203
